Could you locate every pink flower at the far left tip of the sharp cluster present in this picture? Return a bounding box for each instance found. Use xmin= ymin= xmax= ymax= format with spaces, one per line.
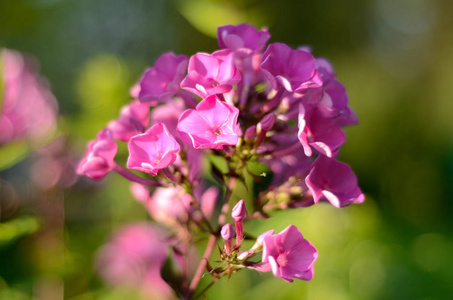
xmin=77 ymin=129 xmax=118 ymax=179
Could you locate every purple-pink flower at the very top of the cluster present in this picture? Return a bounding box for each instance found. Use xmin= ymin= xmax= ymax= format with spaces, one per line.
xmin=217 ymin=24 xmax=271 ymax=57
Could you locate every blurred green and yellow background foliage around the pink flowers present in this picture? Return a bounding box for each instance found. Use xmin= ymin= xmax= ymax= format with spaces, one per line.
xmin=0 ymin=0 xmax=453 ymax=300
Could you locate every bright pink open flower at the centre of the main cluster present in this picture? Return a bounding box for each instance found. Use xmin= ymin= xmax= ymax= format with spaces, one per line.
xmin=177 ymin=96 xmax=239 ymax=149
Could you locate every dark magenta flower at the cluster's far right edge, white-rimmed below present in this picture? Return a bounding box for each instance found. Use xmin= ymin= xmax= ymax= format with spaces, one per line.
xmin=305 ymin=155 xmax=365 ymax=207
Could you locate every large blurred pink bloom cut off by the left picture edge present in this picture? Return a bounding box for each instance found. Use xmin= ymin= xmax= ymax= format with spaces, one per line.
xmin=0 ymin=49 xmax=58 ymax=145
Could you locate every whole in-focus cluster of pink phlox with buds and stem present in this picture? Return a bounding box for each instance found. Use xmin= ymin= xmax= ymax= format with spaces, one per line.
xmin=78 ymin=24 xmax=364 ymax=298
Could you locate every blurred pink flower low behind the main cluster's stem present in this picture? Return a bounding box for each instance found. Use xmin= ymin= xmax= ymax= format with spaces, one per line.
xmin=96 ymin=223 xmax=173 ymax=299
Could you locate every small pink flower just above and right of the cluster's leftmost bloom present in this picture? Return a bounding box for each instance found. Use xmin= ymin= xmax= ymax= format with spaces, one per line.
xmin=107 ymin=100 xmax=149 ymax=142
